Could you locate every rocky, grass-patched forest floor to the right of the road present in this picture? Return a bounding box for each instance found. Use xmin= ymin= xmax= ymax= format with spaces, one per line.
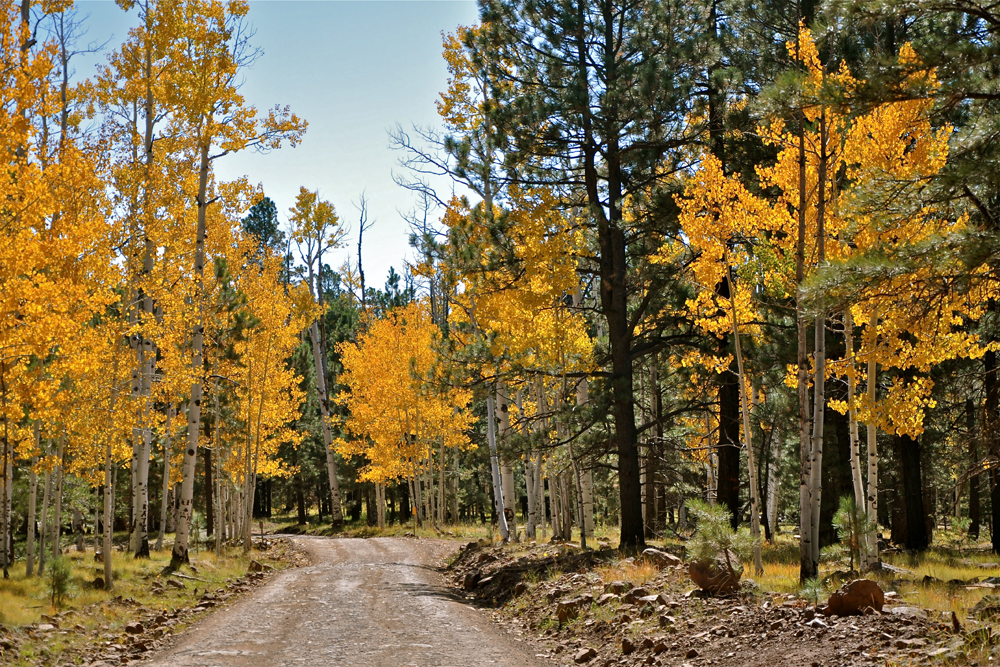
xmin=449 ymin=542 xmax=1000 ymax=667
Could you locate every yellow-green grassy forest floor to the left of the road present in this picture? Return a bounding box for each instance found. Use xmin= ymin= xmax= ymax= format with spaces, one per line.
xmin=0 ymin=538 xmax=306 ymax=667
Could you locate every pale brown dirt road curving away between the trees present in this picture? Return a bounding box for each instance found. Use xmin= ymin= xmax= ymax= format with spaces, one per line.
xmin=146 ymin=537 xmax=552 ymax=667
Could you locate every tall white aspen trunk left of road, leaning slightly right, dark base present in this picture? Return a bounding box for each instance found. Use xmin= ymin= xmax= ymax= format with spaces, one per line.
xmin=170 ymin=142 xmax=208 ymax=570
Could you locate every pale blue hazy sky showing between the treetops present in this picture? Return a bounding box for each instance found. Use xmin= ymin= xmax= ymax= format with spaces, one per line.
xmin=77 ymin=0 xmax=476 ymax=287
